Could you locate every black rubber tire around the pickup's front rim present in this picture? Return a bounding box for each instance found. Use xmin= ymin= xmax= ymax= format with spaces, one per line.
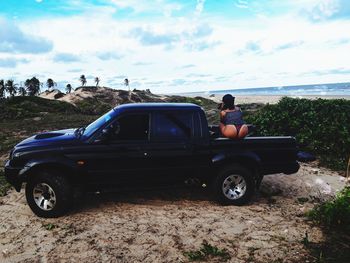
xmin=25 ymin=171 xmax=73 ymax=218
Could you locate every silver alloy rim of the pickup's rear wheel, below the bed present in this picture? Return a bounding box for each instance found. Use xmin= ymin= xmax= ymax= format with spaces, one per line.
xmin=222 ymin=174 xmax=247 ymax=200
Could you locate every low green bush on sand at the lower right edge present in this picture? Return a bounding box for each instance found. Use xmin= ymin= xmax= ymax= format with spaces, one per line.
xmin=307 ymin=186 xmax=350 ymax=234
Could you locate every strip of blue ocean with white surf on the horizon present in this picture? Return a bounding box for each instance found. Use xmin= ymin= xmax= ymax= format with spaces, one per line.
xmin=205 ymin=82 xmax=350 ymax=96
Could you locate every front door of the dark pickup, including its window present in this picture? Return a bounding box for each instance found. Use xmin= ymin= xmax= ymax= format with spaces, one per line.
xmin=86 ymin=113 xmax=150 ymax=188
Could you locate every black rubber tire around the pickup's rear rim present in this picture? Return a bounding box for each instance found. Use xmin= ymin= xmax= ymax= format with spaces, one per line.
xmin=213 ymin=164 xmax=255 ymax=205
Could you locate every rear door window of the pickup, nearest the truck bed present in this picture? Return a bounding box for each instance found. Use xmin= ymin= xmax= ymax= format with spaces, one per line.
xmin=153 ymin=112 xmax=193 ymax=141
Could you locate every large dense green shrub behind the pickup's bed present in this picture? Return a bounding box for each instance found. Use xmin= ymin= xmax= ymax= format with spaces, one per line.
xmin=246 ymin=97 xmax=350 ymax=170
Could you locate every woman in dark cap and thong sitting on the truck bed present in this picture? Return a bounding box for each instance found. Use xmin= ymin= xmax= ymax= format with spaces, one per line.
xmin=219 ymin=94 xmax=248 ymax=139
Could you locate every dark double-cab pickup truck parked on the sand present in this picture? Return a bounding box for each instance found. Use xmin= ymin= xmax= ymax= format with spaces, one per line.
xmin=5 ymin=103 xmax=299 ymax=217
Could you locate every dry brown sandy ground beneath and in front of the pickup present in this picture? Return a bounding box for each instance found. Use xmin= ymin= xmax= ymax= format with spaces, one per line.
xmin=0 ymin=164 xmax=345 ymax=262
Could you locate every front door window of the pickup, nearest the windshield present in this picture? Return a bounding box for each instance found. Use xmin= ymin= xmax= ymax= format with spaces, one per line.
xmin=111 ymin=114 xmax=149 ymax=141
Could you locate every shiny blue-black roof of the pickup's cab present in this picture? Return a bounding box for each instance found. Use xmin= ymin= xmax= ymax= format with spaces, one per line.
xmin=114 ymin=102 xmax=201 ymax=112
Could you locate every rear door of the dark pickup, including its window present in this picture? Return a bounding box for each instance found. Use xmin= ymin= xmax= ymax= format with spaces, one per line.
xmin=143 ymin=110 xmax=208 ymax=187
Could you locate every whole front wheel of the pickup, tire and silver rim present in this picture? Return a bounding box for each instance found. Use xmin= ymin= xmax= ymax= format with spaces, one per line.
xmin=25 ymin=171 xmax=73 ymax=218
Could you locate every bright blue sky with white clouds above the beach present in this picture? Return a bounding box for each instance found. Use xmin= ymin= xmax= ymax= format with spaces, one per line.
xmin=0 ymin=0 xmax=350 ymax=93
